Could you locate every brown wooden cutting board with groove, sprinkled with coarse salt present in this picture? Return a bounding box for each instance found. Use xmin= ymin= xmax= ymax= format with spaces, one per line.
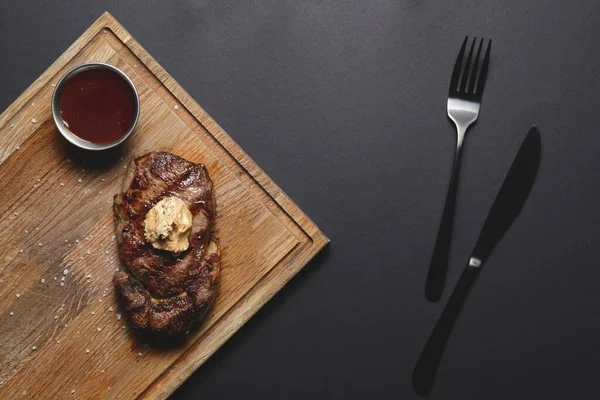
xmin=0 ymin=13 xmax=328 ymax=399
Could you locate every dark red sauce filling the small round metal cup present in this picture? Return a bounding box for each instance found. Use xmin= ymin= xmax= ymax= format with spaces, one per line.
xmin=60 ymin=69 xmax=135 ymax=144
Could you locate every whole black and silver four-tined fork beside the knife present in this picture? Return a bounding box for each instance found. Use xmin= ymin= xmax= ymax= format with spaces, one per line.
xmin=425 ymin=36 xmax=492 ymax=301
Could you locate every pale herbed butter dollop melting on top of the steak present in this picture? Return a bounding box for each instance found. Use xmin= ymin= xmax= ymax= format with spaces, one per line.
xmin=144 ymin=197 xmax=192 ymax=253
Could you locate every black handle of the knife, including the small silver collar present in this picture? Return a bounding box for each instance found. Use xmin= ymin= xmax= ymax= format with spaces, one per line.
xmin=412 ymin=257 xmax=482 ymax=396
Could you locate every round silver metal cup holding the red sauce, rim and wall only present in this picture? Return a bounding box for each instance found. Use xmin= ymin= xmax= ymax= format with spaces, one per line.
xmin=52 ymin=62 xmax=140 ymax=150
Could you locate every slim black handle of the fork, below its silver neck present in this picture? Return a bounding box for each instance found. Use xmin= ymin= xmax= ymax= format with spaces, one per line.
xmin=425 ymin=133 xmax=465 ymax=301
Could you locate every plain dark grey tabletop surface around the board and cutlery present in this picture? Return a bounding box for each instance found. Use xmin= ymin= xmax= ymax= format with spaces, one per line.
xmin=0 ymin=0 xmax=600 ymax=400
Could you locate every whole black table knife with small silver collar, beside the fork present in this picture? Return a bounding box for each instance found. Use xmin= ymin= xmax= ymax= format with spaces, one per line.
xmin=412 ymin=125 xmax=542 ymax=396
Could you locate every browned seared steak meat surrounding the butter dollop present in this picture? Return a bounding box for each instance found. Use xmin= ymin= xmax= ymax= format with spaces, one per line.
xmin=113 ymin=152 xmax=220 ymax=335
